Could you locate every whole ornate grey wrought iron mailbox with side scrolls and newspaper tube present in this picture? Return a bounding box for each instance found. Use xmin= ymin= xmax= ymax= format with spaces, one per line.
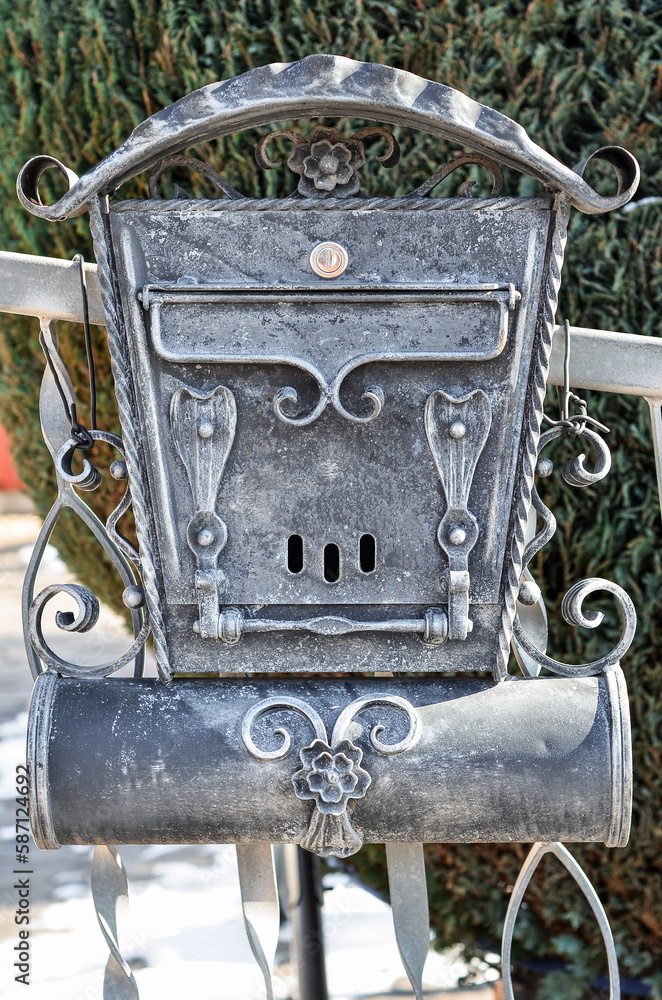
xmin=18 ymin=56 xmax=638 ymax=996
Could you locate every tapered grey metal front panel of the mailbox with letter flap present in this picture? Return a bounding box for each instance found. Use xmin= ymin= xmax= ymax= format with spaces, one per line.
xmin=111 ymin=200 xmax=550 ymax=672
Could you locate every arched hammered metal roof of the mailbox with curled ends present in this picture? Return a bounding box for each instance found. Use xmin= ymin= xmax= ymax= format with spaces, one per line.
xmin=17 ymin=55 xmax=639 ymax=221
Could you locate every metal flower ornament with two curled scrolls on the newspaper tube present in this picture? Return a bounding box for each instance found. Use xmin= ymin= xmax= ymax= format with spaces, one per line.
xmin=241 ymin=695 xmax=421 ymax=858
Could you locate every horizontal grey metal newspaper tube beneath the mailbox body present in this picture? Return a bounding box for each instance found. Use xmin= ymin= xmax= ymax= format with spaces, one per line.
xmin=28 ymin=668 xmax=632 ymax=848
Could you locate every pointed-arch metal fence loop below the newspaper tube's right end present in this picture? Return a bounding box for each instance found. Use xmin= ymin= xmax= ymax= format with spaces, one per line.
xmin=501 ymin=843 xmax=621 ymax=1000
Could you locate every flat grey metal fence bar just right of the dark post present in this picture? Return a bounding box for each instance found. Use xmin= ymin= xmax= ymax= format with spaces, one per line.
xmin=386 ymin=844 xmax=430 ymax=1000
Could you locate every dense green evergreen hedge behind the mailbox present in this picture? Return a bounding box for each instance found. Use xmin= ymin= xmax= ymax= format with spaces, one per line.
xmin=0 ymin=0 xmax=662 ymax=1000
